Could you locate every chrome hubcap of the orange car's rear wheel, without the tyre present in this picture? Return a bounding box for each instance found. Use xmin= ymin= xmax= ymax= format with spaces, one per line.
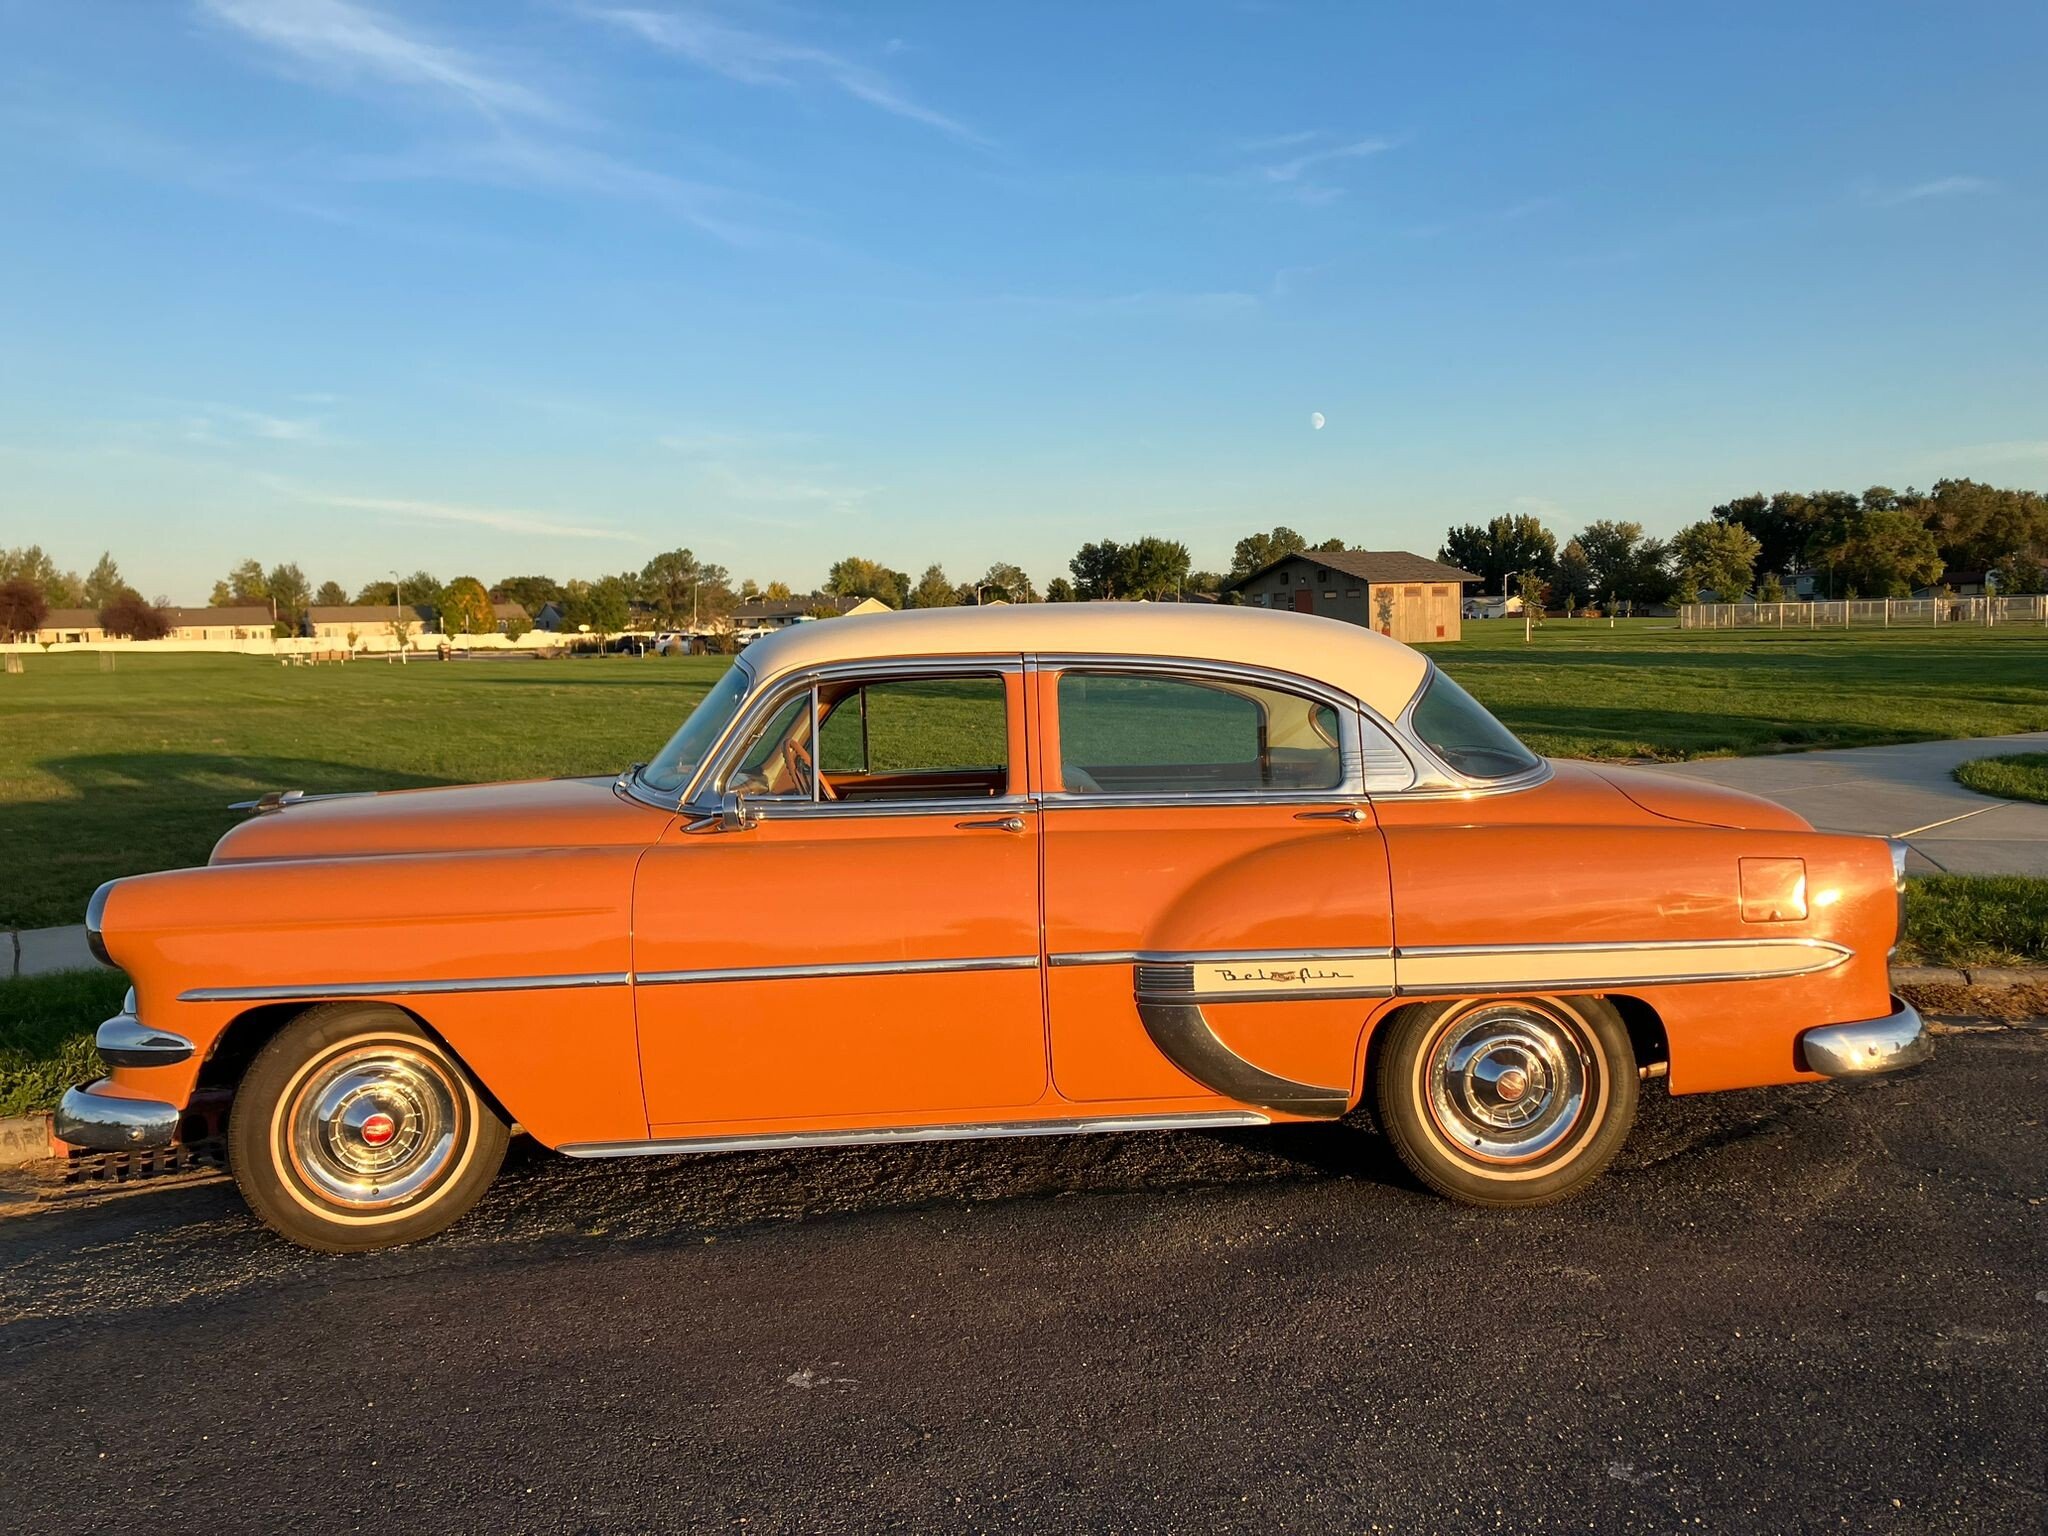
xmin=1423 ymin=1004 xmax=1591 ymax=1163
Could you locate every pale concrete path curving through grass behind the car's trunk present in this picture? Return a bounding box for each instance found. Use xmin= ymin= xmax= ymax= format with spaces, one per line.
xmin=1653 ymin=731 xmax=2048 ymax=874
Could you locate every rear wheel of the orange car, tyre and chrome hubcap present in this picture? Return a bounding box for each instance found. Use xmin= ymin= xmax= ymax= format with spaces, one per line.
xmin=1376 ymin=997 xmax=1636 ymax=1206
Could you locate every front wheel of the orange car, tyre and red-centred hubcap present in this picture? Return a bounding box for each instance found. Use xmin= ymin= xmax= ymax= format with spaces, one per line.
xmin=227 ymin=1004 xmax=510 ymax=1253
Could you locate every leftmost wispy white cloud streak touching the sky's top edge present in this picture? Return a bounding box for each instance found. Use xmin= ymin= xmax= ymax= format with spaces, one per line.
xmin=199 ymin=0 xmax=561 ymax=119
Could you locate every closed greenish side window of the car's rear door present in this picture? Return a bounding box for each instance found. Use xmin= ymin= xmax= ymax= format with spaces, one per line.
xmin=1059 ymin=672 xmax=1343 ymax=795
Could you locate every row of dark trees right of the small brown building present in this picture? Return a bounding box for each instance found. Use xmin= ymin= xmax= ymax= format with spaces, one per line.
xmin=1438 ymin=479 xmax=2048 ymax=610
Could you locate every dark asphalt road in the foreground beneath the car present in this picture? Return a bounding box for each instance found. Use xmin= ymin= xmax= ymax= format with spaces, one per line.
xmin=0 ymin=1026 xmax=2048 ymax=1532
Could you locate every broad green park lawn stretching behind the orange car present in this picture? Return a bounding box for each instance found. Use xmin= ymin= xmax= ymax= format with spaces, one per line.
xmin=0 ymin=618 xmax=2048 ymax=928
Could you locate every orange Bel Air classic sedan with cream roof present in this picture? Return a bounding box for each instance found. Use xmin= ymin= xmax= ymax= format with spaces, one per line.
xmin=57 ymin=604 xmax=1929 ymax=1249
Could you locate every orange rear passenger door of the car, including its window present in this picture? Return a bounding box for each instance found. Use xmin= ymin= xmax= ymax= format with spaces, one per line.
xmin=1036 ymin=659 xmax=1405 ymax=1116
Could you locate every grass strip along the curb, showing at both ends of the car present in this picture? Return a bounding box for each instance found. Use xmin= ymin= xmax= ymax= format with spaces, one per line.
xmin=0 ymin=874 xmax=2048 ymax=1114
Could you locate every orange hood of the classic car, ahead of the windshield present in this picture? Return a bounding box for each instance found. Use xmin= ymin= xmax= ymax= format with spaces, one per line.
xmin=213 ymin=778 xmax=672 ymax=864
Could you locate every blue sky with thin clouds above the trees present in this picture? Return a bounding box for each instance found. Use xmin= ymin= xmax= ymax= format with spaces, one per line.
xmin=0 ymin=0 xmax=2048 ymax=600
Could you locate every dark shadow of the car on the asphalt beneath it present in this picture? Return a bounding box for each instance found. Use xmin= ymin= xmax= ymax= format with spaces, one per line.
xmin=0 ymin=1085 xmax=1833 ymax=1331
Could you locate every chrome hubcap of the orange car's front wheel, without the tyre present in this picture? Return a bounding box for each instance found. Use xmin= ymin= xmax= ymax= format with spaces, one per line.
xmin=289 ymin=1044 xmax=463 ymax=1208
